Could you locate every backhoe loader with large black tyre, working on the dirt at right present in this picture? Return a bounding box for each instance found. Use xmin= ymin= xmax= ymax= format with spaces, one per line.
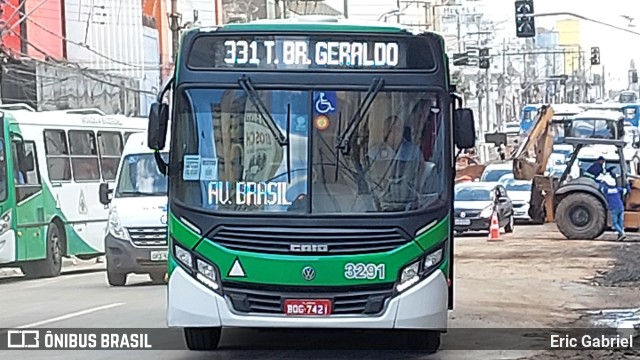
xmin=512 ymin=105 xmax=640 ymax=240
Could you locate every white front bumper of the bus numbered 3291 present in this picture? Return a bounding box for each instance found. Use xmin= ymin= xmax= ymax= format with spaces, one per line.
xmin=167 ymin=267 xmax=448 ymax=330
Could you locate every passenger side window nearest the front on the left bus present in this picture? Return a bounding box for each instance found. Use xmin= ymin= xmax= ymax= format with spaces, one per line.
xmin=44 ymin=129 xmax=71 ymax=181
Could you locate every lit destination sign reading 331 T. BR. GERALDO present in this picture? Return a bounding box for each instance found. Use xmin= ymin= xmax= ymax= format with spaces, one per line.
xmin=187 ymin=35 xmax=434 ymax=70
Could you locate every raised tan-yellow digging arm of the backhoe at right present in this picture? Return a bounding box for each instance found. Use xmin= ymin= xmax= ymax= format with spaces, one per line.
xmin=513 ymin=105 xmax=554 ymax=180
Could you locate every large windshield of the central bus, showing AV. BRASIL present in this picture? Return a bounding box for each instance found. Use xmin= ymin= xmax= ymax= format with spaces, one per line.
xmin=170 ymin=88 xmax=448 ymax=213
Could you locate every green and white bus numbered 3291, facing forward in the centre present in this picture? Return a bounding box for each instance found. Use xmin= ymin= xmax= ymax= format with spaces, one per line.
xmin=148 ymin=18 xmax=475 ymax=350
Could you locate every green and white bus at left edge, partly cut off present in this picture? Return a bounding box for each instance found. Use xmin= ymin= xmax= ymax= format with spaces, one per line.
xmin=0 ymin=104 xmax=148 ymax=278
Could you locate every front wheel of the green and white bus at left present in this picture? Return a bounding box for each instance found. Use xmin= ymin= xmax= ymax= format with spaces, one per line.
xmin=22 ymin=223 xmax=63 ymax=279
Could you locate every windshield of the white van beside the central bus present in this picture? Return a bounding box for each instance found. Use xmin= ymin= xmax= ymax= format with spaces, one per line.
xmin=115 ymin=153 xmax=169 ymax=197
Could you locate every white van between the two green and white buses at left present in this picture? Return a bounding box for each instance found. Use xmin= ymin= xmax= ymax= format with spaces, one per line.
xmin=100 ymin=133 xmax=169 ymax=286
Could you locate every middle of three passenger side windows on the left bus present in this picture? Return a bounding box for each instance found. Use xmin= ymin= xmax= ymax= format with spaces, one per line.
xmin=69 ymin=130 xmax=100 ymax=181
